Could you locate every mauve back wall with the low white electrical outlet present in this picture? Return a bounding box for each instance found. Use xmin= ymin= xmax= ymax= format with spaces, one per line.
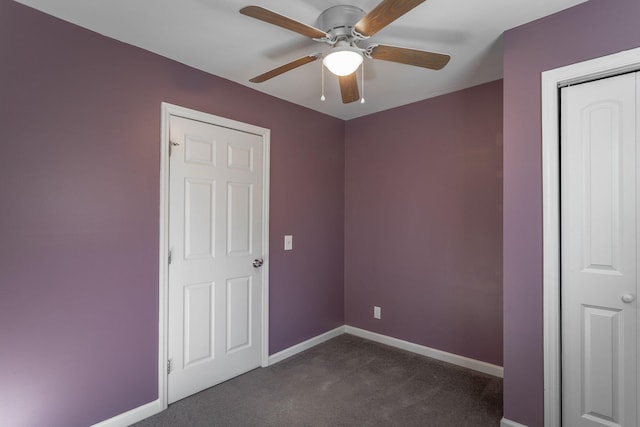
xmin=345 ymin=80 xmax=503 ymax=365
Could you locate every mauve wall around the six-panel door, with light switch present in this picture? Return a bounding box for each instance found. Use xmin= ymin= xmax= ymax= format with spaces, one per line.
xmin=0 ymin=0 xmax=344 ymax=427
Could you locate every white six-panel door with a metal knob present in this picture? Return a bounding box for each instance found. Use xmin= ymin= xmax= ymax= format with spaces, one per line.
xmin=168 ymin=116 xmax=264 ymax=403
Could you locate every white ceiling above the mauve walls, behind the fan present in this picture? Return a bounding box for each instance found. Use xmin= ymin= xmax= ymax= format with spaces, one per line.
xmin=18 ymin=0 xmax=586 ymax=119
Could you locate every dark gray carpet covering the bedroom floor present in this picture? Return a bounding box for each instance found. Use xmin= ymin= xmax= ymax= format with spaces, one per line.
xmin=135 ymin=335 xmax=502 ymax=427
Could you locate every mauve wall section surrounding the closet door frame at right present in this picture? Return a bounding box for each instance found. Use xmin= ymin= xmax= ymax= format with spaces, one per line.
xmin=504 ymin=0 xmax=640 ymax=427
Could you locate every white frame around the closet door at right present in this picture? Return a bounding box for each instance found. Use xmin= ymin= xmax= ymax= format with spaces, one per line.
xmin=542 ymin=48 xmax=640 ymax=427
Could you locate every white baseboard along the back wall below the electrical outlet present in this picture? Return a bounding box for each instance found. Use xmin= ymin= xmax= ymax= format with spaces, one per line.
xmin=345 ymin=326 xmax=504 ymax=378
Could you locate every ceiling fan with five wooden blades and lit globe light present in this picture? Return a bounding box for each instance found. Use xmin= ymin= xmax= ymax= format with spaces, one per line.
xmin=240 ymin=0 xmax=451 ymax=104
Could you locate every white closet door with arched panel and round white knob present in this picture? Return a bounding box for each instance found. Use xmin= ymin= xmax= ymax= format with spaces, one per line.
xmin=560 ymin=74 xmax=640 ymax=427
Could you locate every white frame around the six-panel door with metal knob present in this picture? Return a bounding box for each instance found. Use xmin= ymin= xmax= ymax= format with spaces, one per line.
xmin=158 ymin=102 xmax=271 ymax=410
